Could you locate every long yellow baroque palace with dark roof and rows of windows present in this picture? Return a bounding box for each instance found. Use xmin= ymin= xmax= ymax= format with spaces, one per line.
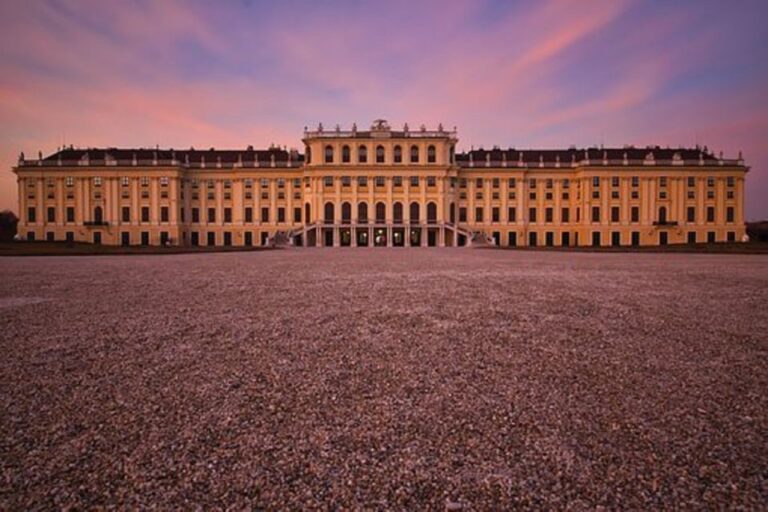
xmin=13 ymin=120 xmax=749 ymax=247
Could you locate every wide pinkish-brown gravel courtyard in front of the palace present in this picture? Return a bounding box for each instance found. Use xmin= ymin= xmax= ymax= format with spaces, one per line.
xmin=0 ymin=249 xmax=768 ymax=510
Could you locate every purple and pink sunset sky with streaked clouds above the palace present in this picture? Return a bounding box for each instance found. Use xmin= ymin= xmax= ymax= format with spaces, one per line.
xmin=0 ymin=0 xmax=768 ymax=220
